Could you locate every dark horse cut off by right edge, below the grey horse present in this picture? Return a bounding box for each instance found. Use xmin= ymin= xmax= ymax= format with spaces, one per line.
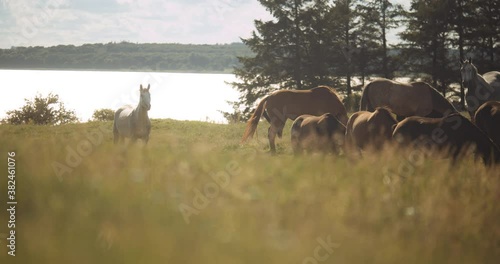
xmin=474 ymin=101 xmax=500 ymax=147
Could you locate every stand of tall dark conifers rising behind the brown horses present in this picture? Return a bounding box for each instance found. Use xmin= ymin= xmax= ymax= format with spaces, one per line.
xmin=227 ymin=0 xmax=500 ymax=121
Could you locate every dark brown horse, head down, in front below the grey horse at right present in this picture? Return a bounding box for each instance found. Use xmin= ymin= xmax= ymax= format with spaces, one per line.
xmin=392 ymin=113 xmax=500 ymax=165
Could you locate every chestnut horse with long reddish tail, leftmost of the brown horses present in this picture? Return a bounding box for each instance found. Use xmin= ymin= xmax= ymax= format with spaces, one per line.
xmin=241 ymin=86 xmax=347 ymax=152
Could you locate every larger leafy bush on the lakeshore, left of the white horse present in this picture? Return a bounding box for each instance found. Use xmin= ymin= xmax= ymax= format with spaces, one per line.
xmin=3 ymin=93 xmax=78 ymax=125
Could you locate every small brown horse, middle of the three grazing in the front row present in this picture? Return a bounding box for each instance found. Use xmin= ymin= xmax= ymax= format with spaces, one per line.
xmin=346 ymin=107 xmax=398 ymax=150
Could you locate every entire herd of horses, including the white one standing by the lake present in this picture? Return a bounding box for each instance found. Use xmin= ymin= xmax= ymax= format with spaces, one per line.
xmin=113 ymin=59 xmax=500 ymax=165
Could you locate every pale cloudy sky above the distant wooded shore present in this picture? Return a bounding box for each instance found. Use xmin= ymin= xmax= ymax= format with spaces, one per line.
xmin=0 ymin=0 xmax=410 ymax=48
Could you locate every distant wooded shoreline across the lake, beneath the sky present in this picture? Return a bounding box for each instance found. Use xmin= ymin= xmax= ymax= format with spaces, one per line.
xmin=0 ymin=41 xmax=251 ymax=72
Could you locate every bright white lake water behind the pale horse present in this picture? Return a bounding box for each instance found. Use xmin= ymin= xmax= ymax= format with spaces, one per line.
xmin=0 ymin=70 xmax=242 ymax=123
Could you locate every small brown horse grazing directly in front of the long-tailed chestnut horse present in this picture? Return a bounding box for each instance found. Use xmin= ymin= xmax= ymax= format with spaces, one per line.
xmin=291 ymin=113 xmax=345 ymax=154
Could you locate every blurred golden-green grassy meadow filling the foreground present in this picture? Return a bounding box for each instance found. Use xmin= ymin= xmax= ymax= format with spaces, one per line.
xmin=0 ymin=120 xmax=500 ymax=264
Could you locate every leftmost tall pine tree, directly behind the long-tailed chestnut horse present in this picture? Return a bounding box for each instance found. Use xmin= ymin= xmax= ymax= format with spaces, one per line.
xmin=231 ymin=0 xmax=329 ymax=119
